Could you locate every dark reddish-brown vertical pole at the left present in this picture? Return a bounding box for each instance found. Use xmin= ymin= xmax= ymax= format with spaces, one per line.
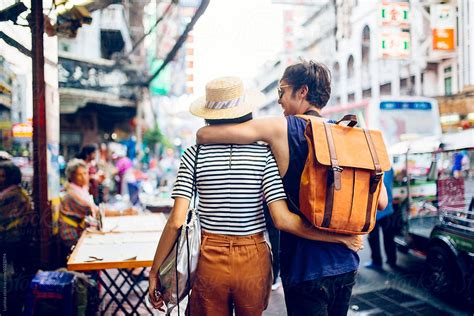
xmin=30 ymin=0 xmax=51 ymax=267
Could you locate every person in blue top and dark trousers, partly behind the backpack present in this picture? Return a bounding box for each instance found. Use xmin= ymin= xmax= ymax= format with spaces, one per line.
xmin=365 ymin=169 xmax=397 ymax=270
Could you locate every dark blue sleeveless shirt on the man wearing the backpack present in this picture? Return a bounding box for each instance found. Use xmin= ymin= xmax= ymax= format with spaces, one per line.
xmin=280 ymin=116 xmax=359 ymax=285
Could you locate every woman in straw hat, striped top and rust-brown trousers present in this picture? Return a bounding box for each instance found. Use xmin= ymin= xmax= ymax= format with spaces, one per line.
xmin=149 ymin=77 xmax=360 ymax=315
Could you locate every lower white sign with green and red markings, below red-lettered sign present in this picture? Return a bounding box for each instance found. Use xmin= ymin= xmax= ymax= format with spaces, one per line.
xmin=380 ymin=31 xmax=411 ymax=59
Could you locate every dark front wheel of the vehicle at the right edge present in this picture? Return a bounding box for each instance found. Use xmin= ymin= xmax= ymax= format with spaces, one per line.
xmin=423 ymin=246 xmax=459 ymax=298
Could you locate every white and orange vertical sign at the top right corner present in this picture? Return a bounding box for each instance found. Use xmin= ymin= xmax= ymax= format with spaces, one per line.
xmin=430 ymin=4 xmax=456 ymax=51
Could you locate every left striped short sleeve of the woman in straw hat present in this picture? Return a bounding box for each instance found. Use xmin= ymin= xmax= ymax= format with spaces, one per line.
xmin=171 ymin=145 xmax=197 ymax=200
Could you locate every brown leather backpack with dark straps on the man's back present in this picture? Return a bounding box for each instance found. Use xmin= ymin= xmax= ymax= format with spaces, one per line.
xmin=298 ymin=115 xmax=390 ymax=235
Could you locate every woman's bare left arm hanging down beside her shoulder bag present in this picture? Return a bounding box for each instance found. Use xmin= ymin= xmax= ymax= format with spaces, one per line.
xmin=148 ymin=197 xmax=189 ymax=310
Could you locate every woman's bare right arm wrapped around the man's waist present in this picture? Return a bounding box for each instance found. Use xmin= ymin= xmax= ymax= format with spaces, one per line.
xmin=268 ymin=200 xmax=363 ymax=251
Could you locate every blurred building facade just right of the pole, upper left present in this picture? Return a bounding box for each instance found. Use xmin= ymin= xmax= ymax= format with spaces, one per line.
xmin=59 ymin=0 xmax=149 ymax=158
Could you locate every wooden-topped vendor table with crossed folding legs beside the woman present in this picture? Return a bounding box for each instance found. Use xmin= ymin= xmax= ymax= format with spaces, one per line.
xmin=67 ymin=215 xmax=166 ymax=315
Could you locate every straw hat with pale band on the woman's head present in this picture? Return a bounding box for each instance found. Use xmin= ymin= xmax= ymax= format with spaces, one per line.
xmin=189 ymin=77 xmax=265 ymax=120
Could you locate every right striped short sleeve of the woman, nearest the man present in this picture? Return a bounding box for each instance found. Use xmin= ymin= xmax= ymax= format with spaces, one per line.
xmin=262 ymin=148 xmax=286 ymax=204
